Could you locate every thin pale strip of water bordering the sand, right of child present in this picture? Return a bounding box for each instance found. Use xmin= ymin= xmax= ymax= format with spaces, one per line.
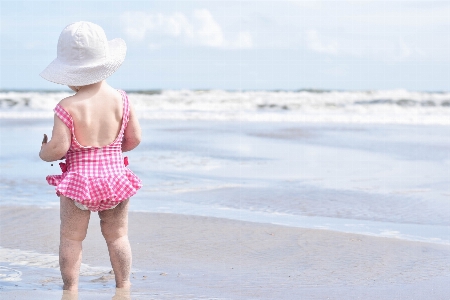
xmin=133 ymin=200 xmax=450 ymax=245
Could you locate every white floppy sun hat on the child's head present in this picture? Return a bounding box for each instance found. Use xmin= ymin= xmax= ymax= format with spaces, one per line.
xmin=40 ymin=21 xmax=127 ymax=86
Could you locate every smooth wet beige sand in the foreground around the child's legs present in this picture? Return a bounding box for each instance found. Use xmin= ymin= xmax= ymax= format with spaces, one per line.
xmin=0 ymin=207 xmax=450 ymax=299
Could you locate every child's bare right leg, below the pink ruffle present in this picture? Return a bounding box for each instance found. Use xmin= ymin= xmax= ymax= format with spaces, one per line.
xmin=98 ymin=199 xmax=131 ymax=288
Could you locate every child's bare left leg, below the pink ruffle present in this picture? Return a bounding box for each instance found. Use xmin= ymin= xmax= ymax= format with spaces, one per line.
xmin=59 ymin=196 xmax=91 ymax=291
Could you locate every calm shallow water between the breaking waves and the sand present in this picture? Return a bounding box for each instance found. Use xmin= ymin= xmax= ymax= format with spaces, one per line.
xmin=0 ymin=120 xmax=450 ymax=243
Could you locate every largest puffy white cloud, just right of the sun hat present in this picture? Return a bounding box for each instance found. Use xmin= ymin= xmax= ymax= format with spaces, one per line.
xmin=120 ymin=9 xmax=253 ymax=49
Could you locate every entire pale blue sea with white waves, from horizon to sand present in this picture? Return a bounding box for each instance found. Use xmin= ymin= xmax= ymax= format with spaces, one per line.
xmin=0 ymin=90 xmax=450 ymax=299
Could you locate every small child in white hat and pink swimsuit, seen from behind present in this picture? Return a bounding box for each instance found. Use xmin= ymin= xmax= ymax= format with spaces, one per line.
xmin=39 ymin=22 xmax=142 ymax=291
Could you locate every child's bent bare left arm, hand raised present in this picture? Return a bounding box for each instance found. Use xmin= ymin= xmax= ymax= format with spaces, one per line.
xmin=39 ymin=115 xmax=71 ymax=162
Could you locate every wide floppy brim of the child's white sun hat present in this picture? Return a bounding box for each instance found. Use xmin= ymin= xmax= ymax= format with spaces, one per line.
xmin=39 ymin=38 xmax=127 ymax=86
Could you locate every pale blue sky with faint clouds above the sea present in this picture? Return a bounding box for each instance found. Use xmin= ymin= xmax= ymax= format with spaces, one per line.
xmin=0 ymin=0 xmax=450 ymax=91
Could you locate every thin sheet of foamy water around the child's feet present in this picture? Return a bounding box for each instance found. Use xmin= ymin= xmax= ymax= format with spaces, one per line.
xmin=0 ymin=247 xmax=232 ymax=300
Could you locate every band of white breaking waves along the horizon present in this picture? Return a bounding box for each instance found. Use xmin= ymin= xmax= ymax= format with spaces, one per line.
xmin=0 ymin=89 xmax=450 ymax=125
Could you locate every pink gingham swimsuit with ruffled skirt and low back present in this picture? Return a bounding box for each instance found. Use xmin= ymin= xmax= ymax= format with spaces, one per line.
xmin=46 ymin=90 xmax=142 ymax=211
